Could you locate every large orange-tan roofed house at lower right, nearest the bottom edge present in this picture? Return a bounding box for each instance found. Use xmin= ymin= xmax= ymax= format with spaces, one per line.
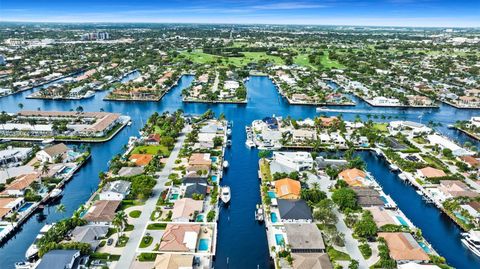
xmin=378 ymin=230 xmax=430 ymax=263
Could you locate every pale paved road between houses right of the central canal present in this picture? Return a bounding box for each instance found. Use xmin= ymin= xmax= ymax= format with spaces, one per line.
xmin=320 ymin=176 xmax=368 ymax=269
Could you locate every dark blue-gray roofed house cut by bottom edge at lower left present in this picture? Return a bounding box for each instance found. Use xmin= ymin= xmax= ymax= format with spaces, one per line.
xmin=36 ymin=249 xmax=88 ymax=269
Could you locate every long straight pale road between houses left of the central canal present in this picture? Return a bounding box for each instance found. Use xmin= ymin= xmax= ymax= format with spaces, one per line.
xmin=115 ymin=126 xmax=190 ymax=269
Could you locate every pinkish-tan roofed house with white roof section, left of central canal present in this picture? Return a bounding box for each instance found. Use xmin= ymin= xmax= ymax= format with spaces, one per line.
xmin=158 ymin=224 xmax=200 ymax=252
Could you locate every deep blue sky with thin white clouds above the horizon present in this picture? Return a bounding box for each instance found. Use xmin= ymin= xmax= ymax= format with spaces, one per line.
xmin=0 ymin=0 xmax=480 ymax=27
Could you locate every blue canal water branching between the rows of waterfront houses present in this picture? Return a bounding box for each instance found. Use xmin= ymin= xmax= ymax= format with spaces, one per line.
xmin=0 ymin=74 xmax=480 ymax=268
